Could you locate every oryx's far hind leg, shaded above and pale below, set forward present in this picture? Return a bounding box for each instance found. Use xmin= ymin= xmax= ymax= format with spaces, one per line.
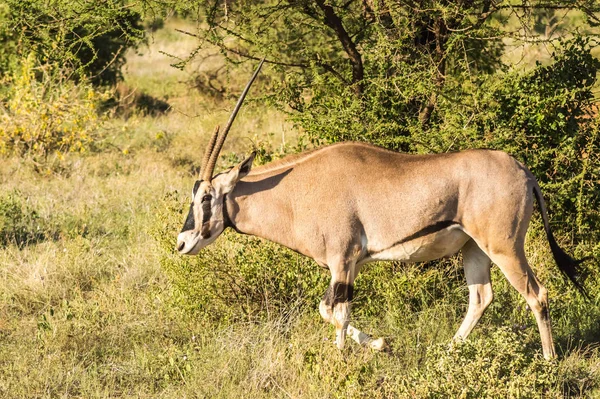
xmin=454 ymin=239 xmax=494 ymax=340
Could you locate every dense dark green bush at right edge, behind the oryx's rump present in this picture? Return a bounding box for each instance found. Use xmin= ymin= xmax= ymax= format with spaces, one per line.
xmin=496 ymin=38 xmax=600 ymax=239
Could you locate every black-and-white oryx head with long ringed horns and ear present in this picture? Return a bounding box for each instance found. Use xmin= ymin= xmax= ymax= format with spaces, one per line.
xmin=177 ymin=60 xmax=264 ymax=255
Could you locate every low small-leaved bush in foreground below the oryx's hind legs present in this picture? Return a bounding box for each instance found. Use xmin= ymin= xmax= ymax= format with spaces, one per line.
xmin=407 ymin=328 xmax=561 ymax=398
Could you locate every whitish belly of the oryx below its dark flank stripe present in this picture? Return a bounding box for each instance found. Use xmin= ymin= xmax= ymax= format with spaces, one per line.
xmin=360 ymin=225 xmax=470 ymax=263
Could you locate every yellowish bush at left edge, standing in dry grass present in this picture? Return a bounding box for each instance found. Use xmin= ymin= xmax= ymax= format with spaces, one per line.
xmin=0 ymin=55 xmax=107 ymax=163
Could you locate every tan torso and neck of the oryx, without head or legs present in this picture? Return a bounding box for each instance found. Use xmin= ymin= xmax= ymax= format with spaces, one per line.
xmin=230 ymin=143 xmax=524 ymax=268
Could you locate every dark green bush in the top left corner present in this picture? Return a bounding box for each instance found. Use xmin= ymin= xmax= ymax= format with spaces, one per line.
xmin=0 ymin=0 xmax=143 ymax=84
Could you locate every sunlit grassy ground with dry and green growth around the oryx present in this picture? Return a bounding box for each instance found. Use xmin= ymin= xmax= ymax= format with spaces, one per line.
xmin=0 ymin=21 xmax=600 ymax=398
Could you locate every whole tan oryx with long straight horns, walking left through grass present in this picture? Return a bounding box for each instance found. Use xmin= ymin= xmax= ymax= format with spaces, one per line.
xmin=177 ymin=60 xmax=583 ymax=358
